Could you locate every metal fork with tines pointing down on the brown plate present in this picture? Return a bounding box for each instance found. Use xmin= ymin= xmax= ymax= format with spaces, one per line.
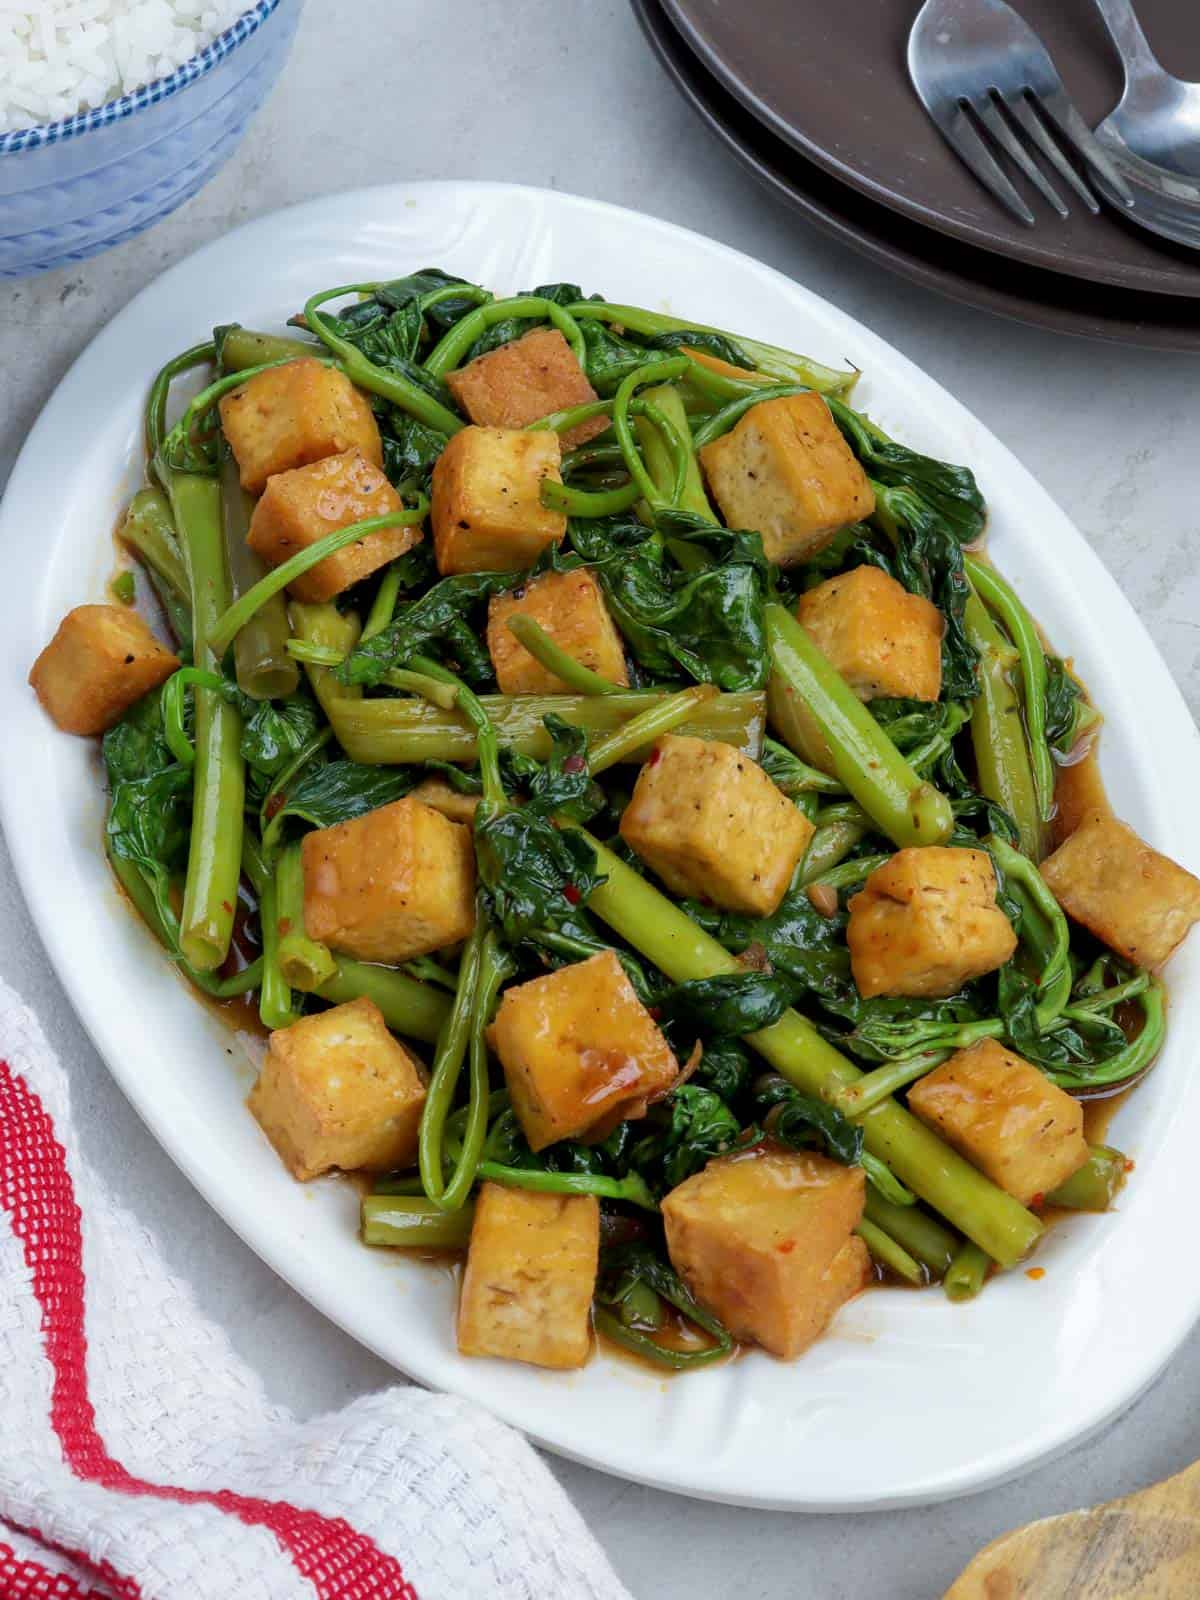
xmin=909 ymin=0 xmax=1133 ymax=227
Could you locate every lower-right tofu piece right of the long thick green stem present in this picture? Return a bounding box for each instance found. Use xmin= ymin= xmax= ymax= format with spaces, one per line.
xmin=909 ymin=1038 xmax=1088 ymax=1205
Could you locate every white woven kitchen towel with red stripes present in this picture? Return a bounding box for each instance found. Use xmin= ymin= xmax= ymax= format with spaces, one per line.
xmin=0 ymin=982 xmax=640 ymax=1600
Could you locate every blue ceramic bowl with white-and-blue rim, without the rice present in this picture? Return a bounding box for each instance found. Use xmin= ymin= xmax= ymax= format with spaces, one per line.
xmin=0 ymin=0 xmax=301 ymax=278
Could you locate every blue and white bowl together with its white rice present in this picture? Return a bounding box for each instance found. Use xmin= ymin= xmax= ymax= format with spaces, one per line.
xmin=0 ymin=0 xmax=301 ymax=278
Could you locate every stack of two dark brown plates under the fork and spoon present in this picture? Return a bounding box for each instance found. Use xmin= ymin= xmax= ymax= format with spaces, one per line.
xmin=632 ymin=0 xmax=1200 ymax=350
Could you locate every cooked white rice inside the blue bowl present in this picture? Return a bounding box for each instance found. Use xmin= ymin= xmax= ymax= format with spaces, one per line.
xmin=0 ymin=0 xmax=250 ymax=133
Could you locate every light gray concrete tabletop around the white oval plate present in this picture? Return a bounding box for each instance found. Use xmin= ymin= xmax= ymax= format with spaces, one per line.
xmin=0 ymin=0 xmax=1200 ymax=1600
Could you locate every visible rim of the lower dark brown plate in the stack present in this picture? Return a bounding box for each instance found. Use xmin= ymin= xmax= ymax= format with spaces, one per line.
xmin=632 ymin=0 xmax=1200 ymax=350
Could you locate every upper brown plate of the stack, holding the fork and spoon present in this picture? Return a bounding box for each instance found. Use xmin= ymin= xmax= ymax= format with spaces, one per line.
xmin=662 ymin=0 xmax=1200 ymax=296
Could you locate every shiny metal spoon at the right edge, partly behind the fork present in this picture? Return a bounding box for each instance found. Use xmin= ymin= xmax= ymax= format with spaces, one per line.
xmin=1093 ymin=0 xmax=1200 ymax=246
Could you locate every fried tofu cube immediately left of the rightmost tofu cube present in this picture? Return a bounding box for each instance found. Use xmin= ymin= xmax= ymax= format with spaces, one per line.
xmin=846 ymin=845 xmax=1016 ymax=1000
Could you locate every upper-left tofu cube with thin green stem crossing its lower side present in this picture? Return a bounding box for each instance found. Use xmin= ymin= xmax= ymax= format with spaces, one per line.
xmin=246 ymin=450 xmax=422 ymax=605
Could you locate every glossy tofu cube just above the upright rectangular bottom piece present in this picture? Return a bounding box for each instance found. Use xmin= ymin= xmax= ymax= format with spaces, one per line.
xmin=488 ymin=950 xmax=678 ymax=1150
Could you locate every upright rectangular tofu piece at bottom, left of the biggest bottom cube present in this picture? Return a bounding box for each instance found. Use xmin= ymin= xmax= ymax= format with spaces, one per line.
xmin=458 ymin=1184 xmax=600 ymax=1368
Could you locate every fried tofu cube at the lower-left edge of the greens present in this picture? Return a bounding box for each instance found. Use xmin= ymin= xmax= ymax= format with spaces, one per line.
xmin=248 ymin=998 xmax=426 ymax=1181
